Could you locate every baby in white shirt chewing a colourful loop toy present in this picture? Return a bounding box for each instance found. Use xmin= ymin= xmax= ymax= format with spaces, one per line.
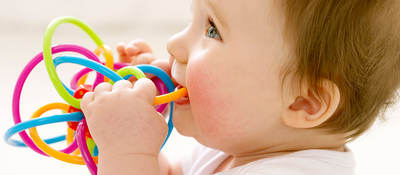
xmin=81 ymin=0 xmax=400 ymax=175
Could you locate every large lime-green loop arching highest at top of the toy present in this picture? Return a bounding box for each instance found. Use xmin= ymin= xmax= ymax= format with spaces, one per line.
xmin=43 ymin=16 xmax=103 ymax=109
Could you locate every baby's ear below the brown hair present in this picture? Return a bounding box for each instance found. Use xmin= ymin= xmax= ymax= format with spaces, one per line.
xmin=282 ymin=79 xmax=340 ymax=128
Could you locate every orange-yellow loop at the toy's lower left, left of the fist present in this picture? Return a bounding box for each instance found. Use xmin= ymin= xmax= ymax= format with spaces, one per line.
xmin=29 ymin=103 xmax=98 ymax=165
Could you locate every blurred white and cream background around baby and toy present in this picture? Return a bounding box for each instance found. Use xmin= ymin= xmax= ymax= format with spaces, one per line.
xmin=0 ymin=0 xmax=400 ymax=175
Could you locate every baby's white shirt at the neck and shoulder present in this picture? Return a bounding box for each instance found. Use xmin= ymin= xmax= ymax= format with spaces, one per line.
xmin=181 ymin=144 xmax=355 ymax=175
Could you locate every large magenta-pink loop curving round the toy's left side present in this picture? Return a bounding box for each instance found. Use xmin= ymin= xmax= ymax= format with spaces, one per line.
xmin=12 ymin=44 xmax=103 ymax=156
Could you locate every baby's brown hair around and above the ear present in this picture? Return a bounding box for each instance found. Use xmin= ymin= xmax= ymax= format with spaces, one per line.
xmin=282 ymin=0 xmax=400 ymax=140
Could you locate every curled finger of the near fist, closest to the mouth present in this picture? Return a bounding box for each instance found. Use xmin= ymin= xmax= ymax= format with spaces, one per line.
xmin=132 ymin=78 xmax=157 ymax=104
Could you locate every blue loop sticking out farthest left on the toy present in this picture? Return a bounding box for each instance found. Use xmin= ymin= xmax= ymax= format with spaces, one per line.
xmin=4 ymin=112 xmax=83 ymax=147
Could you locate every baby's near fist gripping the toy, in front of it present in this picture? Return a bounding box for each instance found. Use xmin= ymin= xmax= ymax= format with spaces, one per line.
xmin=81 ymin=78 xmax=168 ymax=156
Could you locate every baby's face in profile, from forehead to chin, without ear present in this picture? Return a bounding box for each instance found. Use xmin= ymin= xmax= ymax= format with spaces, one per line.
xmin=168 ymin=0 xmax=287 ymax=152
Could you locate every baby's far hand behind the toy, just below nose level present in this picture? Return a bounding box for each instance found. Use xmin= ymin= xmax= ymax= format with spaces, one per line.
xmin=117 ymin=39 xmax=171 ymax=80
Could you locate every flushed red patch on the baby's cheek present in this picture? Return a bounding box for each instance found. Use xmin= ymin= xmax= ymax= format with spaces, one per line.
xmin=186 ymin=59 xmax=239 ymax=139
